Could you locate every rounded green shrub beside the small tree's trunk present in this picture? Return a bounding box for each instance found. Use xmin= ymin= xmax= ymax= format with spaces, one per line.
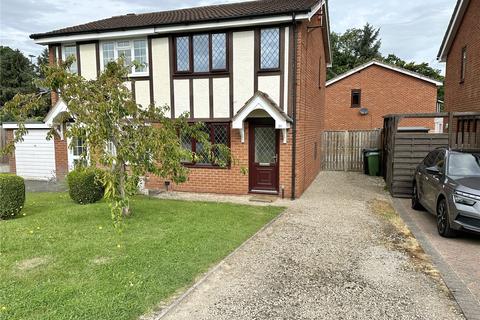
xmin=67 ymin=168 xmax=104 ymax=204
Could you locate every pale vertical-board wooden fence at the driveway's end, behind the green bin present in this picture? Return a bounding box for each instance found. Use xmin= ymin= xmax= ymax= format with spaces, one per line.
xmin=322 ymin=130 xmax=381 ymax=171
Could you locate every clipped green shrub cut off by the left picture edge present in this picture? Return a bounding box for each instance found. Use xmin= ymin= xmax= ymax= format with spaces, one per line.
xmin=0 ymin=174 xmax=25 ymax=218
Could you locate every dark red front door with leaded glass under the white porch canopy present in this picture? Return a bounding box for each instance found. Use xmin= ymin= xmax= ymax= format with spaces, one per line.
xmin=249 ymin=120 xmax=279 ymax=193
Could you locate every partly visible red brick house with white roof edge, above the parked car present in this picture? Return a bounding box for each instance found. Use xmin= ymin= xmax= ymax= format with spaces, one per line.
xmin=438 ymin=0 xmax=480 ymax=112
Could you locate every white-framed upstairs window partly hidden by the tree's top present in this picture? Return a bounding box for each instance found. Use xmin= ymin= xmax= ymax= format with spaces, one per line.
xmin=102 ymin=39 xmax=148 ymax=75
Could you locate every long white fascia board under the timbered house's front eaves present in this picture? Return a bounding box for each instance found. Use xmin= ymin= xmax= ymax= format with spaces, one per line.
xmin=35 ymin=13 xmax=314 ymax=44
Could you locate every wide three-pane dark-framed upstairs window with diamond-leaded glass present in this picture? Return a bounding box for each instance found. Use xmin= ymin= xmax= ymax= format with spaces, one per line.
xmin=175 ymin=33 xmax=227 ymax=74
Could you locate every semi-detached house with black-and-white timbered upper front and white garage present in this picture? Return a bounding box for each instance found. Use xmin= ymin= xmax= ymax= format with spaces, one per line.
xmin=6 ymin=0 xmax=331 ymax=198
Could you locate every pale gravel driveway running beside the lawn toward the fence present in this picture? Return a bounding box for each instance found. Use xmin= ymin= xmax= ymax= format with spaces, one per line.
xmin=153 ymin=172 xmax=463 ymax=320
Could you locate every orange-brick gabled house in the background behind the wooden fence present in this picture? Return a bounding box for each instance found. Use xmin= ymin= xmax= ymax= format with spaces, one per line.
xmin=324 ymin=60 xmax=442 ymax=130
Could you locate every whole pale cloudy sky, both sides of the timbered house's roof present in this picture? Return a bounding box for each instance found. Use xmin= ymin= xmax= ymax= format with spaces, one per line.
xmin=0 ymin=0 xmax=456 ymax=70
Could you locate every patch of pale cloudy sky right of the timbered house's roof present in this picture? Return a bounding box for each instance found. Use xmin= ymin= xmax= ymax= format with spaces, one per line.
xmin=329 ymin=0 xmax=455 ymax=70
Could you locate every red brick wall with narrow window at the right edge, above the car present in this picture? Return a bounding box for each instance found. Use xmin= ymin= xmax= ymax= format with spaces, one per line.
xmin=445 ymin=0 xmax=480 ymax=112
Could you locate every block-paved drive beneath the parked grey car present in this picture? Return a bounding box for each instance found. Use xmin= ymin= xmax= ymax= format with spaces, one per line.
xmin=394 ymin=199 xmax=480 ymax=320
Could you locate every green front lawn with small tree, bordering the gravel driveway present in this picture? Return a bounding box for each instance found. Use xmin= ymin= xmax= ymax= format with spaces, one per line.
xmin=0 ymin=193 xmax=283 ymax=320
